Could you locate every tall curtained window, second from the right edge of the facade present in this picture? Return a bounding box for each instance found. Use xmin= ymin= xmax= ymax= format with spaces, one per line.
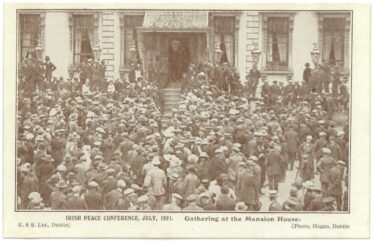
xmin=266 ymin=17 xmax=290 ymax=70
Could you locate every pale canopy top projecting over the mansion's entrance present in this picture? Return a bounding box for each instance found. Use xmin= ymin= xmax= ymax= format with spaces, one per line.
xmin=139 ymin=10 xmax=209 ymax=32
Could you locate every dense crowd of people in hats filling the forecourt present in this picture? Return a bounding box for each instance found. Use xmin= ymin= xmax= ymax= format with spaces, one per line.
xmin=16 ymin=54 xmax=349 ymax=212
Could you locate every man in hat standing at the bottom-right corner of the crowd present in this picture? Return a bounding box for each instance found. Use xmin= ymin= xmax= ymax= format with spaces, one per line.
xmin=327 ymin=160 xmax=345 ymax=211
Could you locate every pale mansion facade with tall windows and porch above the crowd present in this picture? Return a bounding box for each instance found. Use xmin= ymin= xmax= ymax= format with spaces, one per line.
xmin=18 ymin=10 xmax=352 ymax=86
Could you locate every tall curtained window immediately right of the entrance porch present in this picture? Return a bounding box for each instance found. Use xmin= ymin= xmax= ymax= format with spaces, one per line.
xmin=214 ymin=17 xmax=235 ymax=65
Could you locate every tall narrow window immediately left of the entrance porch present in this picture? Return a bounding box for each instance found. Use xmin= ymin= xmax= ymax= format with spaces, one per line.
xmin=123 ymin=15 xmax=144 ymax=66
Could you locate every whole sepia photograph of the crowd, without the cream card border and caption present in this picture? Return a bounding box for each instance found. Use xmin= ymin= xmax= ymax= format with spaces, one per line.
xmin=15 ymin=9 xmax=352 ymax=212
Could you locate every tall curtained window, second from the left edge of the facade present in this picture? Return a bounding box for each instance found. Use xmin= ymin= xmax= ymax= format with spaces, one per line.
xmin=73 ymin=15 xmax=94 ymax=64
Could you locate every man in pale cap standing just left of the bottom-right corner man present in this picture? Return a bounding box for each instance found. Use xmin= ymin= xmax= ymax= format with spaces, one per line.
xmin=317 ymin=148 xmax=335 ymax=194
